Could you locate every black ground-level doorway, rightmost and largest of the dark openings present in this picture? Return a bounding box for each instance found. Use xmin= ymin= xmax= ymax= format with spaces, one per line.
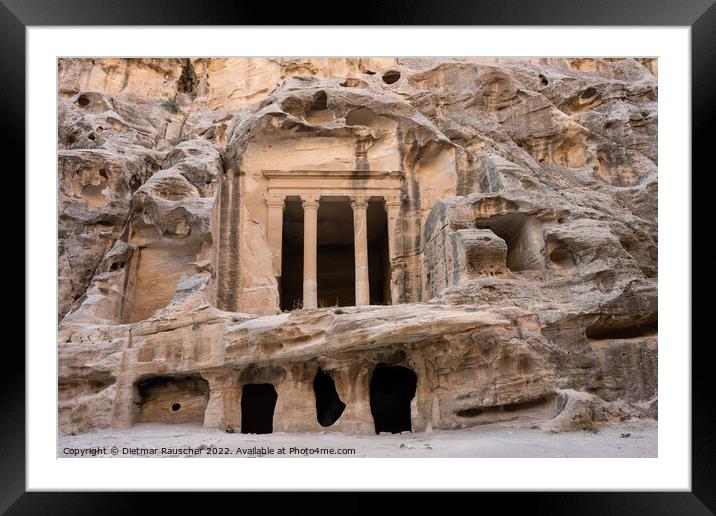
xmin=370 ymin=364 xmax=418 ymax=434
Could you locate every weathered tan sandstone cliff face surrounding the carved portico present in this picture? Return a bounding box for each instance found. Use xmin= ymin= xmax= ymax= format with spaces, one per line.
xmin=58 ymin=58 xmax=658 ymax=433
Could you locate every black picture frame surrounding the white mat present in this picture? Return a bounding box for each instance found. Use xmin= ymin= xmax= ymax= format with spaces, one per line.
xmin=5 ymin=0 xmax=716 ymax=515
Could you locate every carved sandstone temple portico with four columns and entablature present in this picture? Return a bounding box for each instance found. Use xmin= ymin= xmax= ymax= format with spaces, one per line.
xmin=263 ymin=170 xmax=402 ymax=309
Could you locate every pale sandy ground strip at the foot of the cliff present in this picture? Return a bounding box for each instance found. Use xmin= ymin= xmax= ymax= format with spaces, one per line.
xmin=57 ymin=421 xmax=657 ymax=457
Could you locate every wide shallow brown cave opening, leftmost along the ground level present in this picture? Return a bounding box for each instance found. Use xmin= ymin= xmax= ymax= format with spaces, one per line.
xmin=135 ymin=374 xmax=209 ymax=424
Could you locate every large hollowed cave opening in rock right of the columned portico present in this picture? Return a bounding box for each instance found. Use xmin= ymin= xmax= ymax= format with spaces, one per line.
xmin=475 ymin=213 xmax=545 ymax=272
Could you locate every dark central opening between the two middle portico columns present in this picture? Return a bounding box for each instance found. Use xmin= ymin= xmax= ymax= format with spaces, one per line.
xmin=317 ymin=197 xmax=356 ymax=307
